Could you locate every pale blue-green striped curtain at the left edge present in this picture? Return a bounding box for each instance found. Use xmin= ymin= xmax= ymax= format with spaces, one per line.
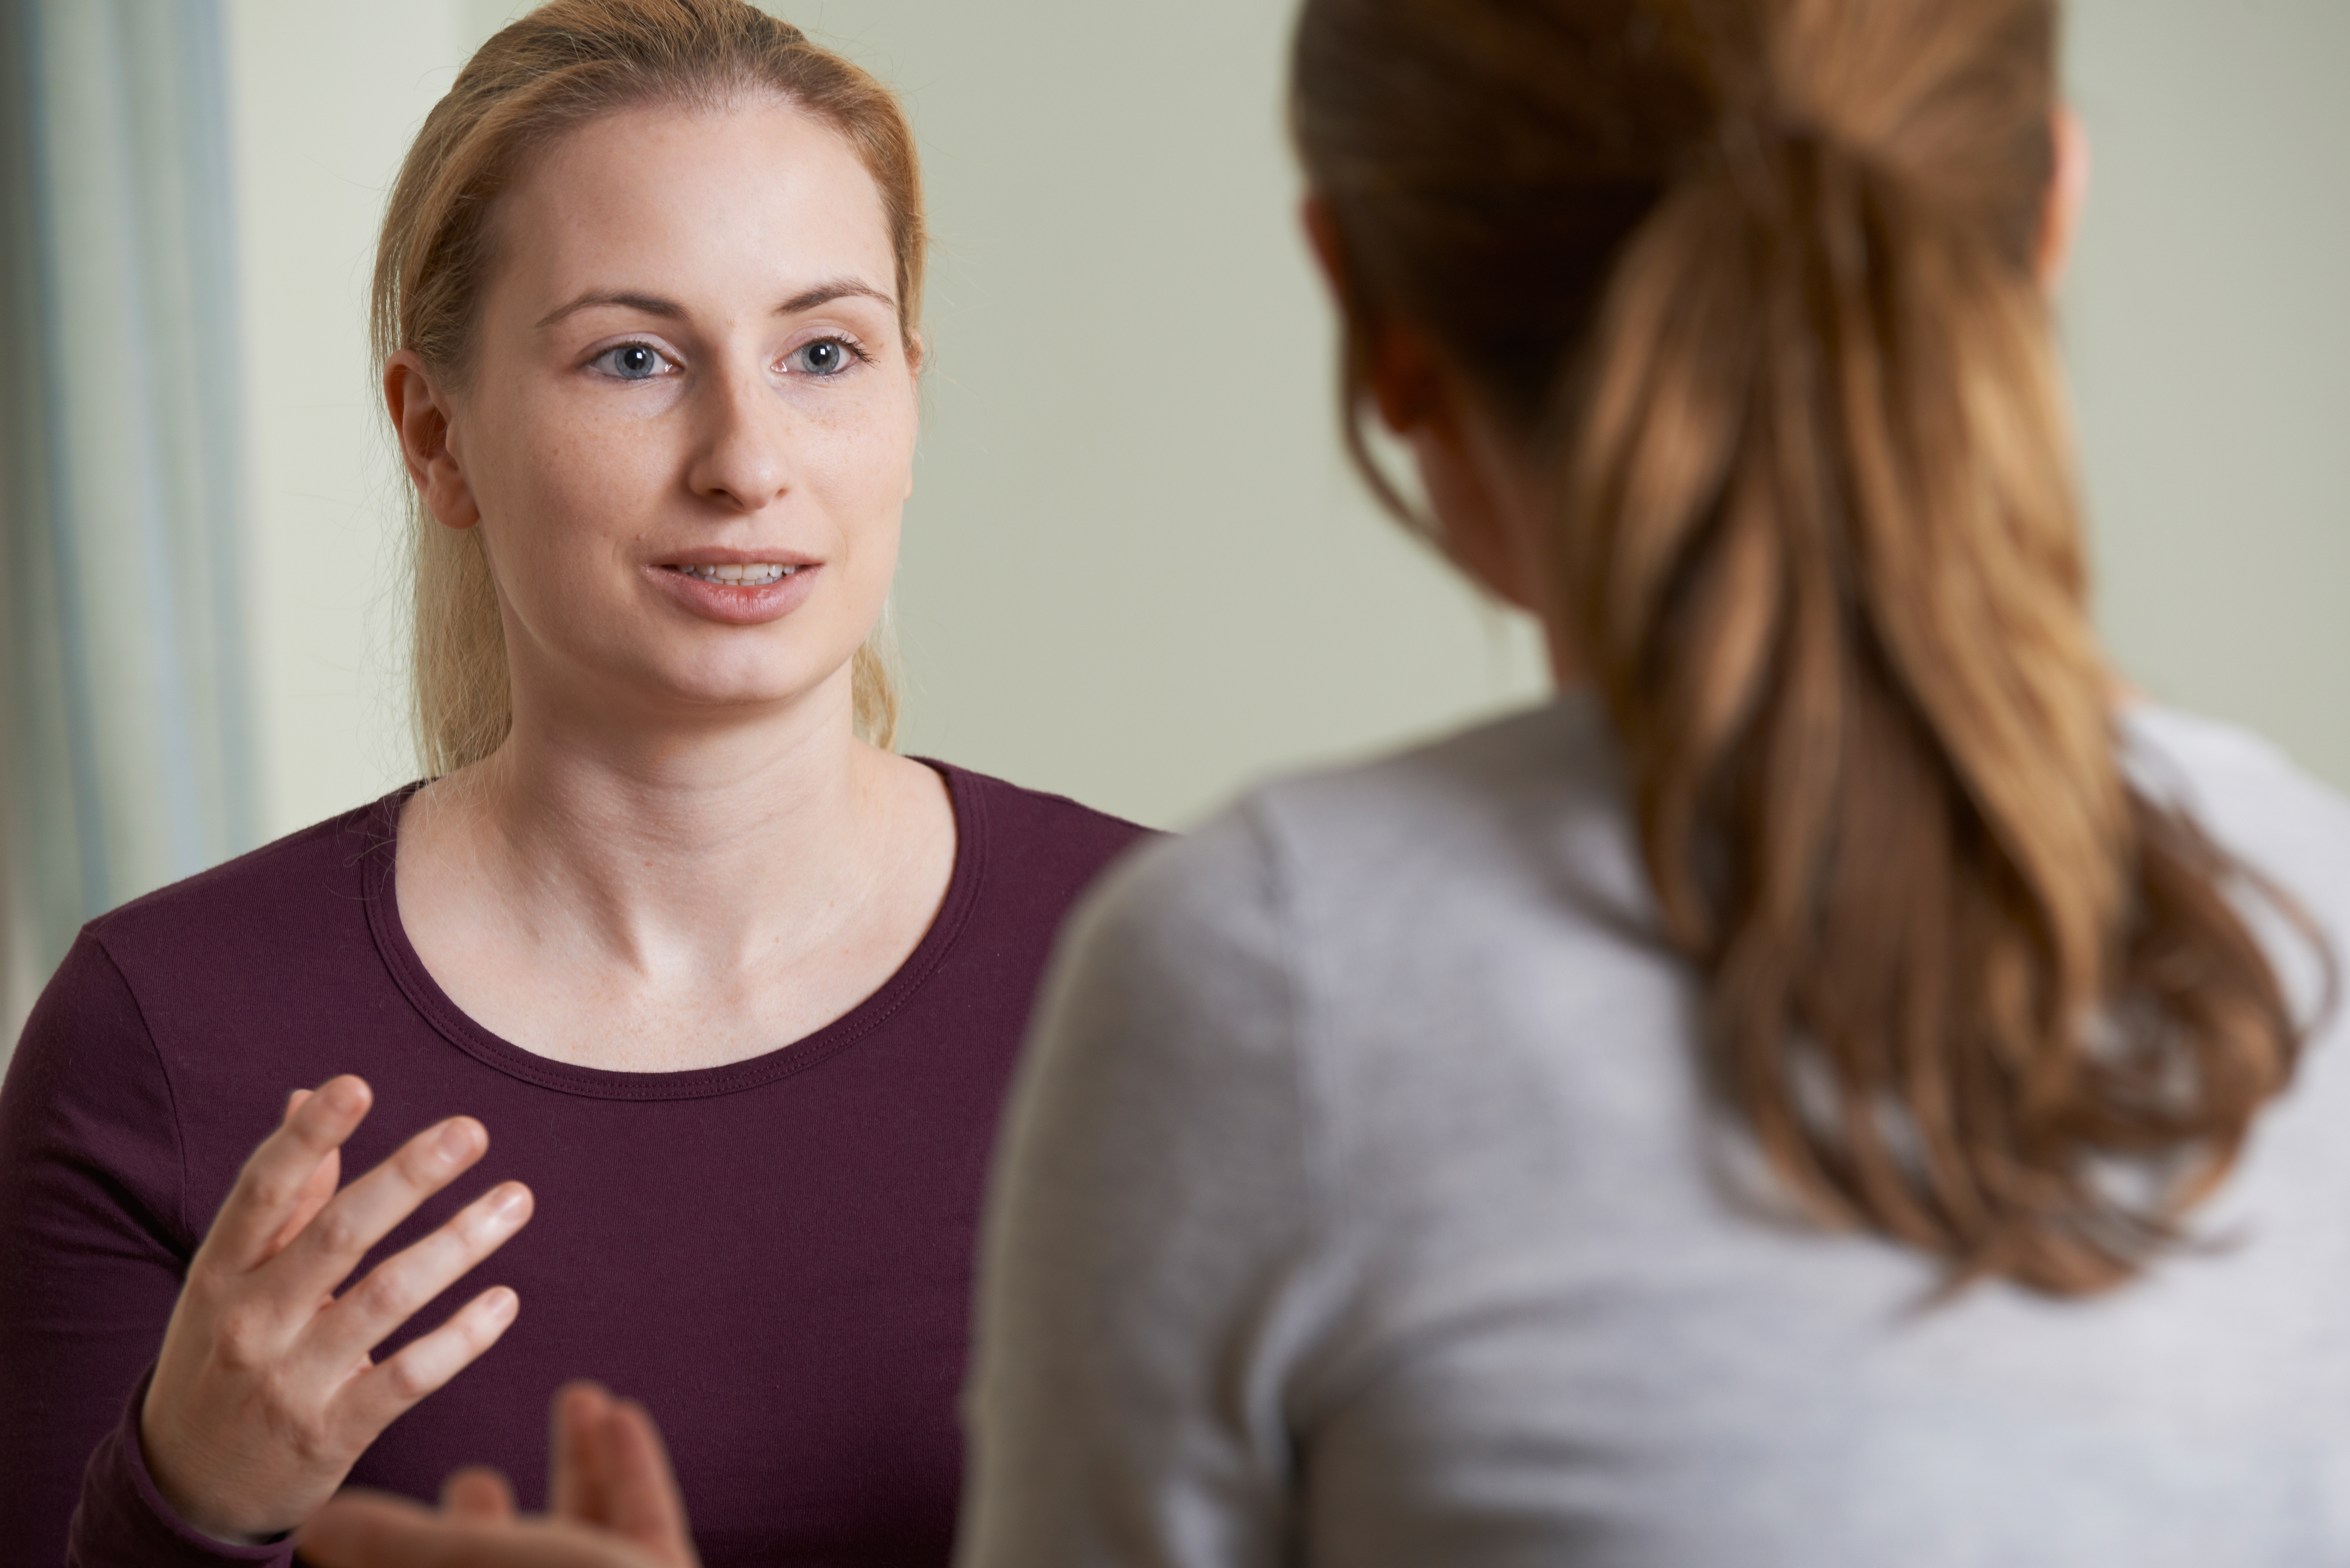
xmin=0 ymin=0 xmax=254 ymax=1053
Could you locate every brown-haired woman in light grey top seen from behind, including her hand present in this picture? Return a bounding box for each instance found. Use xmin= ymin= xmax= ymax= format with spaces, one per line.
xmin=305 ymin=0 xmax=2350 ymax=1568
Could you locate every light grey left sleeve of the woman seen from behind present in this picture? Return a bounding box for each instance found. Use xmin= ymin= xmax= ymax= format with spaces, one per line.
xmin=959 ymin=818 xmax=1328 ymax=1568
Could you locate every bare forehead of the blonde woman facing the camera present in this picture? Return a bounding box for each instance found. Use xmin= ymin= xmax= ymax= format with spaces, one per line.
xmin=496 ymin=99 xmax=898 ymax=310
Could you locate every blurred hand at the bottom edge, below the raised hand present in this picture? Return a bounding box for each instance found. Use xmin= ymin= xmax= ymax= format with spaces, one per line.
xmin=294 ymin=1382 xmax=698 ymax=1568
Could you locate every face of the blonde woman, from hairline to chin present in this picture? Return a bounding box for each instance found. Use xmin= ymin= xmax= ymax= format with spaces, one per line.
xmin=442 ymin=101 xmax=917 ymax=719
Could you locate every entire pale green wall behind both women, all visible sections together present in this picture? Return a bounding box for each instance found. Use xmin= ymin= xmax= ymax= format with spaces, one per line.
xmin=230 ymin=0 xmax=2350 ymax=846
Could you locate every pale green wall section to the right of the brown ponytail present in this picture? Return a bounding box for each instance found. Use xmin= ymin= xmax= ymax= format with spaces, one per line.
xmin=2063 ymin=0 xmax=2350 ymax=788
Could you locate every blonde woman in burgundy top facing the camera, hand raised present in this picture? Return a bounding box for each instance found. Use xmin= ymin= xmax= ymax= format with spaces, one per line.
xmin=0 ymin=0 xmax=1137 ymax=1566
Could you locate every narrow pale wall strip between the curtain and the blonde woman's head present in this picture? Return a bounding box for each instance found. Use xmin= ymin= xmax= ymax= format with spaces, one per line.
xmin=226 ymin=0 xmax=472 ymax=837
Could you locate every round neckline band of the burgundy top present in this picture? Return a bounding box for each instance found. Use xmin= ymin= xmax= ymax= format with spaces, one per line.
xmin=359 ymin=757 xmax=987 ymax=1100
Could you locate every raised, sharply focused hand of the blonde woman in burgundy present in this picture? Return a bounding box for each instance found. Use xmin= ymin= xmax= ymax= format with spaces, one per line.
xmin=139 ymin=1077 xmax=531 ymax=1542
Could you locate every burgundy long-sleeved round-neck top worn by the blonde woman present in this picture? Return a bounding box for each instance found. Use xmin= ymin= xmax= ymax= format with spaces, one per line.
xmin=0 ymin=764 xmax=1142 ymax=1568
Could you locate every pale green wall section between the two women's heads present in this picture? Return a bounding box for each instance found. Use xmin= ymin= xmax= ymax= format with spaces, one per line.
xmin=804 ymin=0 xmax=1539 ymax=823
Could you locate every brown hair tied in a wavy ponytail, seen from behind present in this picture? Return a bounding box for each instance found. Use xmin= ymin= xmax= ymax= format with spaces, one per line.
xmin=1293 ymin=0 xmax=2301 ymax=1293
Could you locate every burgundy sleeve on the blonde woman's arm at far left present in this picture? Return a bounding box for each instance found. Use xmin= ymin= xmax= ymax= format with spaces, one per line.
xmin=0 ymin=933 xmax=291 ymax=1568
